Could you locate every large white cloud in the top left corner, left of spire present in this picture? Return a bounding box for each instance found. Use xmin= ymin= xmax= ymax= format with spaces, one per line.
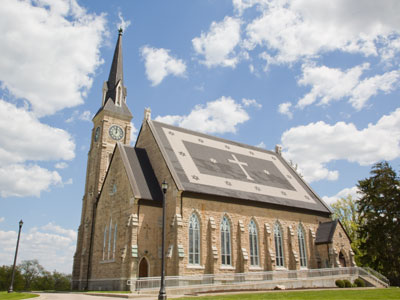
xmin=0 ymin=0 xmax=105 ymax=116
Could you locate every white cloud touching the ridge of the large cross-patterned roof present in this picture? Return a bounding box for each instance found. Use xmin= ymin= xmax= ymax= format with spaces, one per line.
xmin=156 ymin=96 xmax=249 ymax=133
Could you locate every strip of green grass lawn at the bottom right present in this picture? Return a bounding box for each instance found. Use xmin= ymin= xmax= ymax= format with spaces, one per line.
xmin=179 ymin=288 xmax=400 ymax=300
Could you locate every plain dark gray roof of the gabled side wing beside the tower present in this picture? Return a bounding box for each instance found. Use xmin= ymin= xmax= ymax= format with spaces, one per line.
xmin=117 ymin=143 xmax=162 ymax=203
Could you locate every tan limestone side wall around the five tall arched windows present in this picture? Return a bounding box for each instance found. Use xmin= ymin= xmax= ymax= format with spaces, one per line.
xmin=176 ymin=196 xmax=330 ymax=275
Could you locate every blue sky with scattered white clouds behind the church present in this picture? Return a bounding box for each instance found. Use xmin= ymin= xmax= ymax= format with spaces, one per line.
xmin=0 ymin=0 xmax=400 ymax=273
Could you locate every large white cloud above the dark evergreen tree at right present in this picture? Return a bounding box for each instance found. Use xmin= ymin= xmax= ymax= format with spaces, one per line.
xmin=281 ymin=108 xmax=400 ymax=182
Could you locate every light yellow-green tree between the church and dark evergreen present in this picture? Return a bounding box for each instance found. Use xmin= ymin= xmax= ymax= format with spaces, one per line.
xmin=331 ymin=195 xmax=362 ymax=265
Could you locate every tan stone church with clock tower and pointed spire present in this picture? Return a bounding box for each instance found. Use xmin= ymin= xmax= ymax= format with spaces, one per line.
xmin=72 ymin=31 xmax=355 ymax=290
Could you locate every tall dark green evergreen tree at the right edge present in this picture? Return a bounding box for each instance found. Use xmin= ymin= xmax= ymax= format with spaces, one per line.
xmin=356 ymin=162 xmax=400 ymax=285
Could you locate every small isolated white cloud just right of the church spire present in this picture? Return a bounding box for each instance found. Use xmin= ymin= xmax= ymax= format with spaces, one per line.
xmin=141 ymin=46 xmax=186 ymax=86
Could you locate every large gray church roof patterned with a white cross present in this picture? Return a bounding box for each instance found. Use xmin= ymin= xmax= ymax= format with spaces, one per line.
xmin=147 ymin=120 xmax=330 ymax=214
